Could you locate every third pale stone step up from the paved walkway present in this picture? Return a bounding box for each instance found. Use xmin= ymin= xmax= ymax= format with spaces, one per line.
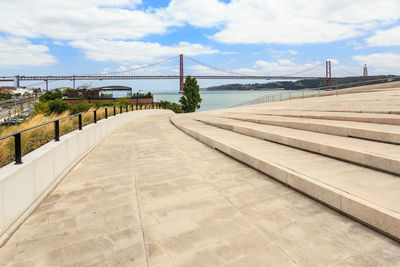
xmin=220 ymin=114 xmax=400 ymax=144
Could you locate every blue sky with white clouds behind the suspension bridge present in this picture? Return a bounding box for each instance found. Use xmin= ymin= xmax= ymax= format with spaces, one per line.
xmin=0 ymin=0 xmax=400 ymax=91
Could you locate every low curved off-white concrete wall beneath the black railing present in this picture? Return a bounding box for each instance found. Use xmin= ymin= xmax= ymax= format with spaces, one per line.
xmin=0 ymin=110 xmax=171 ymax=246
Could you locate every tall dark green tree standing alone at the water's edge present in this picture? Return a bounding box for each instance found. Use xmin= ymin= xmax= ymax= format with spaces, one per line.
xmin=179 ymin=76 xmax=202 ymax=113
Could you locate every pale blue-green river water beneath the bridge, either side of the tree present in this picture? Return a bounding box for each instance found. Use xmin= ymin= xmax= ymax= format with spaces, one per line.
xmin=153 ymin=90 xmax=314 ymax=111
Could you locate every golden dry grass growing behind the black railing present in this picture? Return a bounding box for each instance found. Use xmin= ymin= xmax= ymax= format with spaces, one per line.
xmin=0 ymin=105 xmax=159 ymax=167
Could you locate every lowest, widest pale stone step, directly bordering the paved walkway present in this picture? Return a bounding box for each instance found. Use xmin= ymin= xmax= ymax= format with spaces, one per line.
xmin=171 ymin=115 xmax=400 ymax=240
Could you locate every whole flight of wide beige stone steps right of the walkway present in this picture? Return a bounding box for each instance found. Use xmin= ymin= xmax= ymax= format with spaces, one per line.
xmin=171 ymin=101 xmax=400 ymax=240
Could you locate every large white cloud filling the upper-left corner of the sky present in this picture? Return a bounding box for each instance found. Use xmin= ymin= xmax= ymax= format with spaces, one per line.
xmin=0 ymin=0 xmax=174 ymax=40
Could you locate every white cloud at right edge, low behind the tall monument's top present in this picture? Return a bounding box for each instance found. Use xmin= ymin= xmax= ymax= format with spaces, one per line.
xmin=353 ymin=53 xmax=400 ymax=75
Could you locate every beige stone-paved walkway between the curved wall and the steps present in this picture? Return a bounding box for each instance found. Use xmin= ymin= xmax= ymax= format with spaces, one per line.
xmin=0 ymin=115 xmax=400 ymax=266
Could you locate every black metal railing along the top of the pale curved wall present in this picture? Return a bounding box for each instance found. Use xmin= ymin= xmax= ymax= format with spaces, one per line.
xmin=0 ymin=104 xmax=160 ymax=164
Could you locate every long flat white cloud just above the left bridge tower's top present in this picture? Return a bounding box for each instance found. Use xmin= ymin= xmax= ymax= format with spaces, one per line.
xmin=69 ymin=39 xmax=219 ymax=64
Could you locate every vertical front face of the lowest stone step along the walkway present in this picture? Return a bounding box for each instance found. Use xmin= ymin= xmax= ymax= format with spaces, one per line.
xmin=171 ymin=118 xmax=400 ymax=242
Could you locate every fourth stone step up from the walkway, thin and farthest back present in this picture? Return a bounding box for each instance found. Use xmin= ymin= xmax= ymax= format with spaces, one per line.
xmin=230 ymin=110 xmax=400 ymax=125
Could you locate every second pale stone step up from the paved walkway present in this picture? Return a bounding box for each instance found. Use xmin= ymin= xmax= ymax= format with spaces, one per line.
xmin=197 ymin=117 xmax=400 ymax=176
